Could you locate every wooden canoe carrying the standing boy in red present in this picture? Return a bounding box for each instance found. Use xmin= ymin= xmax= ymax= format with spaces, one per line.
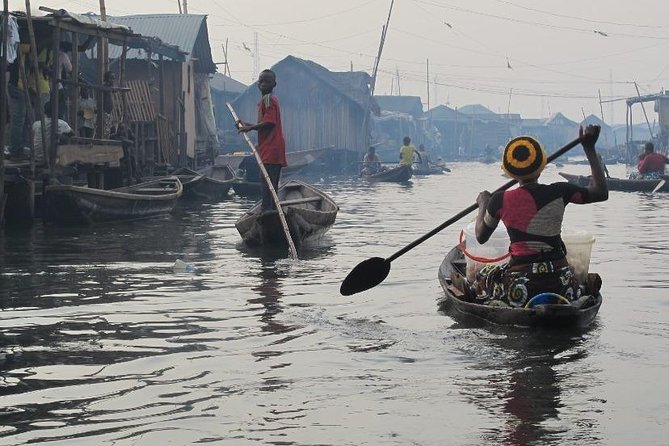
xmin=235 ymin=180 xmax=339 ymax=247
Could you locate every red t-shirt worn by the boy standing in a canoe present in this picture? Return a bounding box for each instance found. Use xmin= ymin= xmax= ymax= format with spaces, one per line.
xmin=258 ymin=94 xmax=288 ymax=167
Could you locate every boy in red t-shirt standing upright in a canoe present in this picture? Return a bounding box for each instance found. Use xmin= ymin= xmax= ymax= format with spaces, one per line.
xmin=238 ymin=70 xmax=287 ymax=211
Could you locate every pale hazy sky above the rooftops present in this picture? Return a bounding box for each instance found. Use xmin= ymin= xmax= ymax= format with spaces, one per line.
xmin=9 ymin=0 xmax=669 ymax=123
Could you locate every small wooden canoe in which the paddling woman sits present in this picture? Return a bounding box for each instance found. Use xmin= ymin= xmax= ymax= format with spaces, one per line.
xmin=439 ymin=247 xmax=602 ymax=328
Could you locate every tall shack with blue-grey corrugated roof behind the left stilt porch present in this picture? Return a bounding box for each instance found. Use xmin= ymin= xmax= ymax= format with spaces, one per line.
xmin=110 ymin=14 xmax=219 ymax=166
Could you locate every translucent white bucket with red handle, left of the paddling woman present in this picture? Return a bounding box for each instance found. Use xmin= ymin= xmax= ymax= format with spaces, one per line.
xmin=463 ymin=221 xmax=511 ymax=282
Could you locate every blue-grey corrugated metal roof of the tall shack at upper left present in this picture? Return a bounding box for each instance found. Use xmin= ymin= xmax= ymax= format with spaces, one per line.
xmin=109 ymin=14 xmax=216 ymax=73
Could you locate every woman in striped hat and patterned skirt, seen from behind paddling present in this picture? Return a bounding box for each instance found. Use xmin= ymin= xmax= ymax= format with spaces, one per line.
xmin=476 ymin=125 xmax=609 ymax=307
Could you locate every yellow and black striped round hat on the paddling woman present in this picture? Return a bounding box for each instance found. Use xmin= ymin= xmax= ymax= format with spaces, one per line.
xmin=502 ymin=136 xmax=547 ymax=180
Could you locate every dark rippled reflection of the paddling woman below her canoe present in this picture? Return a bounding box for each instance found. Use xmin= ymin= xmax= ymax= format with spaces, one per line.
xmin=454 ymin=328 xmax=601 ymax=446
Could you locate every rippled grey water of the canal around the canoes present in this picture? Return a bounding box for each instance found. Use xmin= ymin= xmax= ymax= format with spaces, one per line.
xmin=0 ymin=163 xmax=669 ymax=446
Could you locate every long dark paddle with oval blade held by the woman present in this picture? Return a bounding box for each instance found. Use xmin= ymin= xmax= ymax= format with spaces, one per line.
xmin=339 ymin=138 xmax=581 ymax=296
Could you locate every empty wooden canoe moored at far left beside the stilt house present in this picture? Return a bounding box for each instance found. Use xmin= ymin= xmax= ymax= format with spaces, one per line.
xmin=44 ymin=177 xmax=183 ymax=224
